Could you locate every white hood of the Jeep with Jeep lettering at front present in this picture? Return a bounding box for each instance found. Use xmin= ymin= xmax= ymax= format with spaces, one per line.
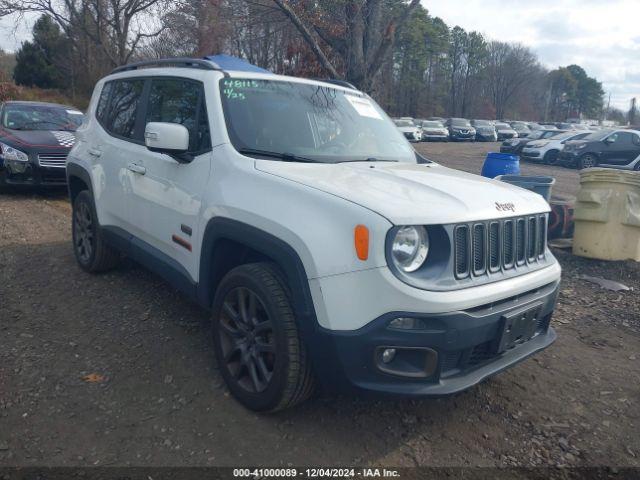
xmin=256 ymin=160 xmax=549 ymax=225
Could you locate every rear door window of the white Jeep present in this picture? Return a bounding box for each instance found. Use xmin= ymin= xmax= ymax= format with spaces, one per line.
xmin=103 ymin=79 xmax=145 ymax=139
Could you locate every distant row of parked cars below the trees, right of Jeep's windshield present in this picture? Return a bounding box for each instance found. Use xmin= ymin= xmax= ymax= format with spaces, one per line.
xmin=393 ymin=117 xmax=594 ymax=142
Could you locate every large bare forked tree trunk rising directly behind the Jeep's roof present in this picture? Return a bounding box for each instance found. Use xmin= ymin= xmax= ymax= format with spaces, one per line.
xmin=273 ymin=0 xmax=420 ymax=91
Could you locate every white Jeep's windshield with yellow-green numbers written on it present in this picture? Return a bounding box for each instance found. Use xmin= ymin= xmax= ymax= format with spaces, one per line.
xmin=220 ymin=78 xmax=417 ymax=163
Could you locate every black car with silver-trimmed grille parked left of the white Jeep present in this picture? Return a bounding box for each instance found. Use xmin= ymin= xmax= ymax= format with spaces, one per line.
xmin=0 ymin=101 xmax=83 ymax=187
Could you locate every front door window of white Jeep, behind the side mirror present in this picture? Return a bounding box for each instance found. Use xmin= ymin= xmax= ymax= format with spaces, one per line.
xmin=145 ymin=78 xmax=211 ymax=153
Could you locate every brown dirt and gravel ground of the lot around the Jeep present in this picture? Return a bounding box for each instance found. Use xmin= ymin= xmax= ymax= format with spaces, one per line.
xmin=0 ymin=144 xmax=640 ymax=467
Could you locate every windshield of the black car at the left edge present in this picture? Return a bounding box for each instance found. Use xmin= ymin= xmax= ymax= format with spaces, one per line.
xmin=2 ymin=103 xmax=84 ymax=132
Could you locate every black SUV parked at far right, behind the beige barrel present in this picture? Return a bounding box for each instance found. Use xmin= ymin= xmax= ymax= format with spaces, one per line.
xmin=558 ymin=129 xmax=640 ymax=170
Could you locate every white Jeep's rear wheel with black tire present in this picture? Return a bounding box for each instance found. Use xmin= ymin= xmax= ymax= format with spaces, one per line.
xmin=71 ymin=190 xmax=121 ymax=273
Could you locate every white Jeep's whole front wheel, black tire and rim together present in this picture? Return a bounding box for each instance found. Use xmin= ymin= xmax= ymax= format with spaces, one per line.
xmin=212 ymin=263 xmax=314 ymax=412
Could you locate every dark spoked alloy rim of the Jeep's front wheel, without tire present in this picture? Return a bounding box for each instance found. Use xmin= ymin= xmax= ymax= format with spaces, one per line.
xmin=219 ymin=287 xmax=276 ymax=393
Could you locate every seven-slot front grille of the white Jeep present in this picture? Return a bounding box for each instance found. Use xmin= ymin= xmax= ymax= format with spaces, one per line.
xmin=453 ymin=214 xmax=547 ymax=279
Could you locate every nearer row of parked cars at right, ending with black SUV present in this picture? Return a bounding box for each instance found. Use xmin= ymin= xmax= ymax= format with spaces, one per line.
xmin=500 ymin=128 xmax=640 ymax=170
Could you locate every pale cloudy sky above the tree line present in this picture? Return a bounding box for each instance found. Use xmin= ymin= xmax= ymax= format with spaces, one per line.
xmin=0 ymin=0 xmax=640 ymax=111
